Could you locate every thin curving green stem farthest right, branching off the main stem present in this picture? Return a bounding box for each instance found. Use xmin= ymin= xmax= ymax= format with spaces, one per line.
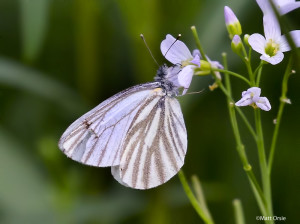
xmin=268 ymin=57 xmax=293 ymax=175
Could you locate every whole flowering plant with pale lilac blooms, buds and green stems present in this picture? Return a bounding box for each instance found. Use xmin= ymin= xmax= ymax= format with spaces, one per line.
xmin=152 ymin=0 xmax=300 ymax=220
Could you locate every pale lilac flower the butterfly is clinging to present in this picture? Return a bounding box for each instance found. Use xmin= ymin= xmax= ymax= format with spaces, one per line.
xmin=160 ymin=34 xmax=200 ymax=95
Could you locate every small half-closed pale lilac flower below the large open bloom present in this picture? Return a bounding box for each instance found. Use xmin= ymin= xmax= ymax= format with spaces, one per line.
xmin=235 ymin=87 xmax=271 ymax=111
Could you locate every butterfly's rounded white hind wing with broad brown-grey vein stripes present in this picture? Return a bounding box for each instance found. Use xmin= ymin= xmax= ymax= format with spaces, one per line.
xmin=112 ymin=89 xmax=187 ymax=189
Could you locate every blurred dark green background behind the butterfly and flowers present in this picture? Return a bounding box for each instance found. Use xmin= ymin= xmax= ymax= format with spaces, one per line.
xmin=0 ymin=0 xmax=300 ymax=224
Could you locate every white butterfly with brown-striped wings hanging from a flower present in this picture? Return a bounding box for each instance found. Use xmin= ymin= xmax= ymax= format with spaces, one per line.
xmin=59 ymin=65 xmax=187 ymax=189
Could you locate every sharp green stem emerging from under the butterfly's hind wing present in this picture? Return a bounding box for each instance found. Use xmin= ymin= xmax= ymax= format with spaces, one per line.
xmin=178 ymin=170 xmax=214 ymax=224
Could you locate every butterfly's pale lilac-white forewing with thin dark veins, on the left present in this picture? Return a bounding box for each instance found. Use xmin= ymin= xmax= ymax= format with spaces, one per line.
xmin=59 ymin=82 xmax=160 ymax=167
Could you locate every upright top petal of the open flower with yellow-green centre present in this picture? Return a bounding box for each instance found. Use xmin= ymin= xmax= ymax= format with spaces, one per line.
xmin=263 ymin=13 xmax=281 ymax=42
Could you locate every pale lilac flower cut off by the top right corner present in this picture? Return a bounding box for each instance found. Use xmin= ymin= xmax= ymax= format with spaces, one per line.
xmin=256 ymin=0 xmax=300 ymax=15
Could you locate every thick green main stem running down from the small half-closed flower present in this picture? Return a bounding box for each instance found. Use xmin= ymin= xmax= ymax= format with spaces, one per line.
xmin=254 ymin=108 xmax=274 ymax=223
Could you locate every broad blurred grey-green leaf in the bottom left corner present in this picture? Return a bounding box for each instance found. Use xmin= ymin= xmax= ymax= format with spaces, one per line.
xmin=0 ymin=128 xmax=54 ymax=223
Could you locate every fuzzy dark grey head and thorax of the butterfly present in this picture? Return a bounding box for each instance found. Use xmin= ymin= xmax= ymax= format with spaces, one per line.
xmin=154 ymin=65 xmax=178 ymax=97
